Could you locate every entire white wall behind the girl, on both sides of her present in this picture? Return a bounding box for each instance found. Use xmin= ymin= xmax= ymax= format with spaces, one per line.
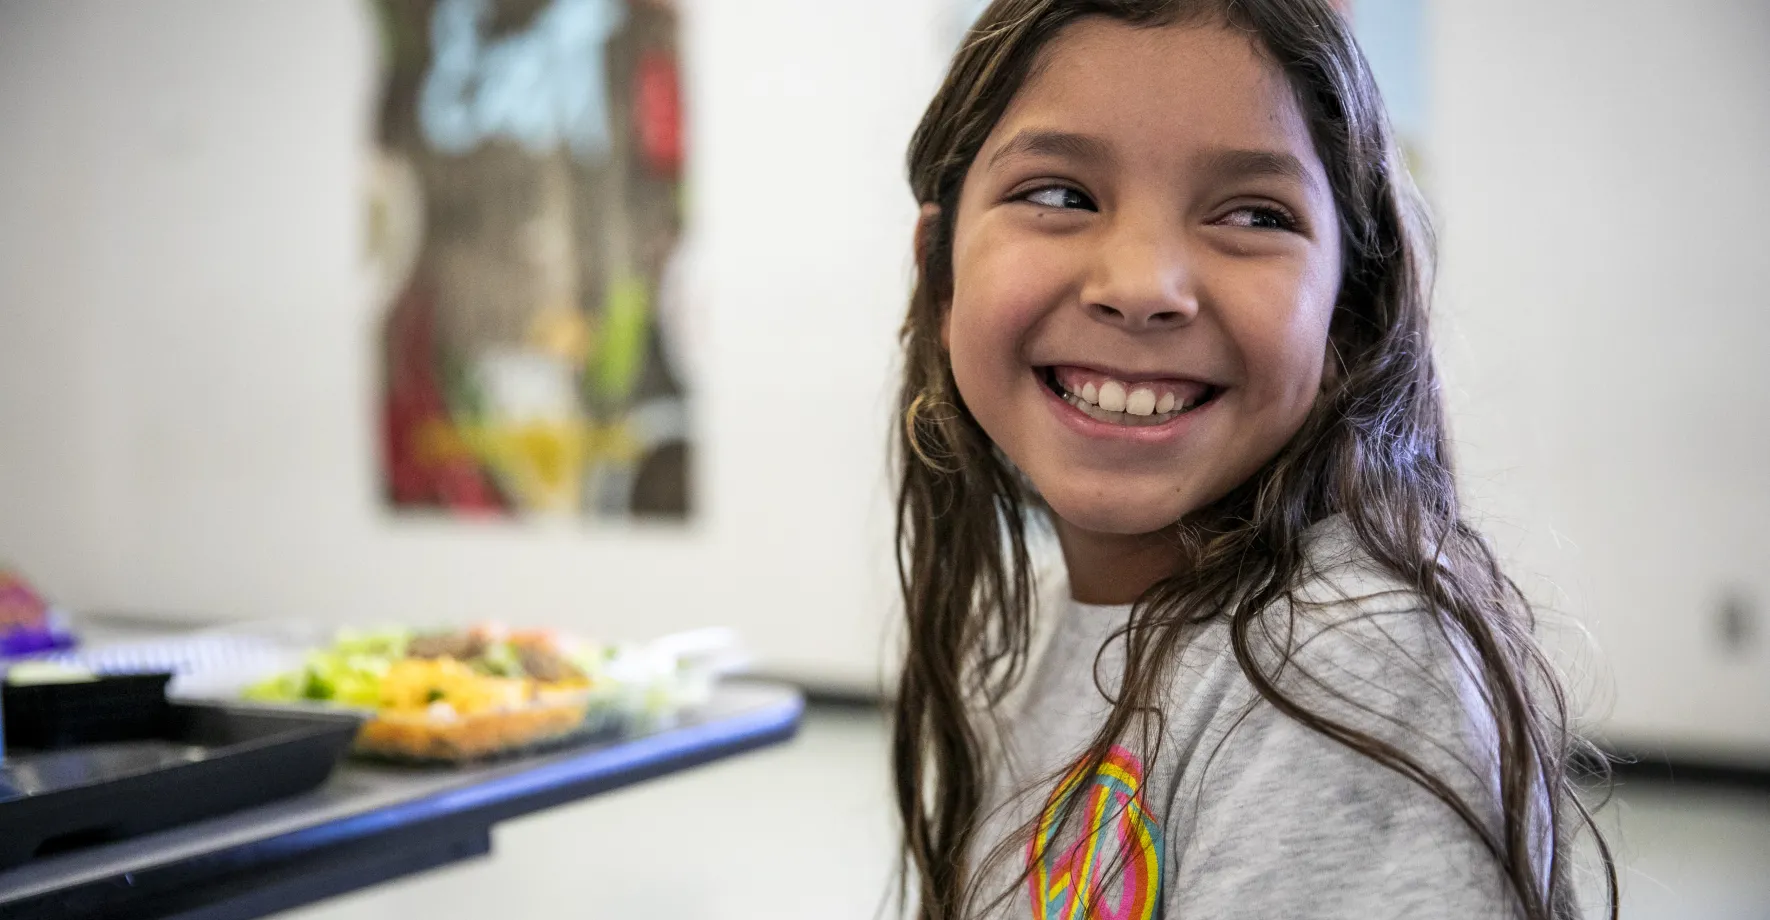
xmin=0 ymin=0 xmax=1770 ymax=757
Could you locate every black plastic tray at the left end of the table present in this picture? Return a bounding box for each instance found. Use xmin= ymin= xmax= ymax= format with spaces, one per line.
xmin=0 ymin=704 xmax=361 ymax=869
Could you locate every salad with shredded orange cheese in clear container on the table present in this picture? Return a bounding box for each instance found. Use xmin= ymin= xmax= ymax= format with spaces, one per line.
xmin=246 ymin=625 xmax=725 ymax=761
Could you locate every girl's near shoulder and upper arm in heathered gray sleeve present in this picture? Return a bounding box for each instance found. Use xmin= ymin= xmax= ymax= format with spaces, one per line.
xmin=1163 ymin=541 xmax=1508 ymax=916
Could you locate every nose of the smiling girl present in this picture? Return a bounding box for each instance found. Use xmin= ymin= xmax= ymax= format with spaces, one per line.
xmin=1081 ymin=234 xmax=1198 ymax=331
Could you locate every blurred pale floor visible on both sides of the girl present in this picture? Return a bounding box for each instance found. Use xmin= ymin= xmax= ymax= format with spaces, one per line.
xmin=285 ymin=713 xmax=1770 ymax=920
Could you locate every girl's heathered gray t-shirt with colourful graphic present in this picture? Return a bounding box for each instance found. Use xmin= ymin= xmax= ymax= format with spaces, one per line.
xmin=972 ymin=520 xmax=1513 ymax=920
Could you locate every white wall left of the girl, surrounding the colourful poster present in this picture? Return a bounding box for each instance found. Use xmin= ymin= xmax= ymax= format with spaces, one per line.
xmin=0 ymin=0 xmax=945 ymax=685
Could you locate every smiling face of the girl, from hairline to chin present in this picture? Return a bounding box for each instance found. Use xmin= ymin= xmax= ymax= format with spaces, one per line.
xmin=943 ymin=19 xmax=1340 ymax=596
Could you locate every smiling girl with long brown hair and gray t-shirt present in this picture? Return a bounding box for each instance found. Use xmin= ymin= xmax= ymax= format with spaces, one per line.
xmin=894 ymin=0 xmax=1614 ymax=920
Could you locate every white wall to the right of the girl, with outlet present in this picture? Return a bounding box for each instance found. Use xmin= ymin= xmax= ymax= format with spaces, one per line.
xmin=1432 ymin=0 xmax=1770 ymax=763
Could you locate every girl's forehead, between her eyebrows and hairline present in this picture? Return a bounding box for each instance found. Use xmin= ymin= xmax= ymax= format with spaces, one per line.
xmin=984 ymin=19 xmax=1313 ymax=167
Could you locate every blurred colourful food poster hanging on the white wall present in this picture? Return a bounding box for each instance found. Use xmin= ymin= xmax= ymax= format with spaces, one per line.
xmin=368 ymin=0 xmax=699 ymax=518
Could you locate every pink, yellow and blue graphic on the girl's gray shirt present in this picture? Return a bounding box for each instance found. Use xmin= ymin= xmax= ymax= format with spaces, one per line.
xmin=1027 ymin=745 xmax=1161 ymax=920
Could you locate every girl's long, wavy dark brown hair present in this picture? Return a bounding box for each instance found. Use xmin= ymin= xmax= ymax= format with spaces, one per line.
xmin=892 ymin=0 xmax=1616 ymax=920
